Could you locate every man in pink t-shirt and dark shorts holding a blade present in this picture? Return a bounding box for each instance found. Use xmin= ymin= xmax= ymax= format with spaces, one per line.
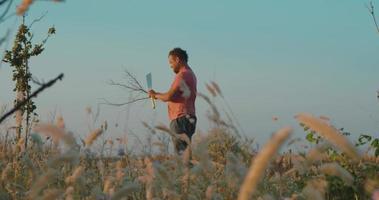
xmin=149 ymin=48 xmax=197 ymax=155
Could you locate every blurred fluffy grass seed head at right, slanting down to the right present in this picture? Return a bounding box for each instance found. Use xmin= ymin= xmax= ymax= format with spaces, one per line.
xmin=295 ymin=113 xmax=360 ymax=160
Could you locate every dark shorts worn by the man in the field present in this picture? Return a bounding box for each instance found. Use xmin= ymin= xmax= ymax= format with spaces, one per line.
xmin=170 ymin=115 xmax=197 ymax=153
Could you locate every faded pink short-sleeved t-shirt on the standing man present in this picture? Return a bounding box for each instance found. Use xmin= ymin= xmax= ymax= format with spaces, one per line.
xmin=168 ymin=67 xmax=197 ymax=120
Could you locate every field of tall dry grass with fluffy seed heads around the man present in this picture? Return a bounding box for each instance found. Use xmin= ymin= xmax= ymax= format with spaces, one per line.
xmin=0 ymin=88 xmax=379 ymax=200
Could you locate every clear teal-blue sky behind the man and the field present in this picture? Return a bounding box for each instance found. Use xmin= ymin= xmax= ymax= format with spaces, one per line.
xmin=0 ymin=0 xmax=379 ymax=144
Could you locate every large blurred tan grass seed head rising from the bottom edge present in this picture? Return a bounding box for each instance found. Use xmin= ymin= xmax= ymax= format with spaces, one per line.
xmin=238 ymin=127 xmax=292 ymax=200
